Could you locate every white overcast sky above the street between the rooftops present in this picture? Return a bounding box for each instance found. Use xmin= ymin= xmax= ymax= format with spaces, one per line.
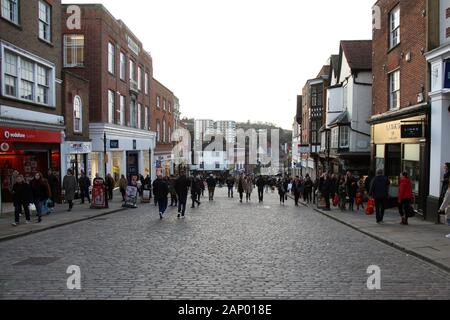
xmin=62 ymin=0 xmax=375 ymax=129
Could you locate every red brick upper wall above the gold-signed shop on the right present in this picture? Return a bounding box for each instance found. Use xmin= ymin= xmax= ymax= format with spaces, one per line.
xmin=372 ymin=0 xmax=428 ymax=115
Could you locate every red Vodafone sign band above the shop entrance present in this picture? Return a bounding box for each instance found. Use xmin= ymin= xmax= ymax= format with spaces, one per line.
xmin=0 ymin=128 xmax=61 ymax=143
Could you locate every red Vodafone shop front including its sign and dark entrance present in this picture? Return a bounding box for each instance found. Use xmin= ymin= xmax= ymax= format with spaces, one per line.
xmin=0 ymin=127 xmax=61 ymax=202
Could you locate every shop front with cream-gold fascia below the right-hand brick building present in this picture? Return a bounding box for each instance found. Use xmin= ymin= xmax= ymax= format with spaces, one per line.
xmin=372 ymin=115 xmax=428 ymax=213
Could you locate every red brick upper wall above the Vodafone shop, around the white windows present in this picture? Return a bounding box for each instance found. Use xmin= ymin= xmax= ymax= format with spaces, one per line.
xmin=0 ymin=0 xmax=62 ymax=115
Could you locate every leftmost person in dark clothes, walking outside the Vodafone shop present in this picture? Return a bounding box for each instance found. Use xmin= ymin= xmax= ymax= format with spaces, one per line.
xmin=11 ymin=174 xmax=33 ymax=227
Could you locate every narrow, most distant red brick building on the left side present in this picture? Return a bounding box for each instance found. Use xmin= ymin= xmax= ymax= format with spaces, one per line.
xmin=151 ymin=78 xmax=178 ymax=176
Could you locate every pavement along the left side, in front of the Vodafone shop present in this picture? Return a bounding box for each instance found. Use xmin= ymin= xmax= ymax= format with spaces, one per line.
xmin=0 ymin=192 xmax=124 ymax=241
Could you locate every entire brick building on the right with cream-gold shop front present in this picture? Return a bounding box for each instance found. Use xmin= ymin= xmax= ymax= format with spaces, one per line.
xmin=369 ymin=0 xmax=436 ymax=219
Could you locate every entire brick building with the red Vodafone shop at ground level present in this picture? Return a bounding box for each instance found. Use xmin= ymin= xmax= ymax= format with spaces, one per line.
xmin=0 ymin=0 xmax=64 ymax=201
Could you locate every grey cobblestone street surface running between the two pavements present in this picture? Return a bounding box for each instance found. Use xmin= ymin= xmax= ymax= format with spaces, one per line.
xmin=0 ymin=189 xmax=450 ymax=300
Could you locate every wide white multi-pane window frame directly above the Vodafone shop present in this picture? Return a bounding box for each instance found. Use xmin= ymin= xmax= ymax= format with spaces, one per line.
xmin=0 ymin=41 xmax=56 ymax=109
